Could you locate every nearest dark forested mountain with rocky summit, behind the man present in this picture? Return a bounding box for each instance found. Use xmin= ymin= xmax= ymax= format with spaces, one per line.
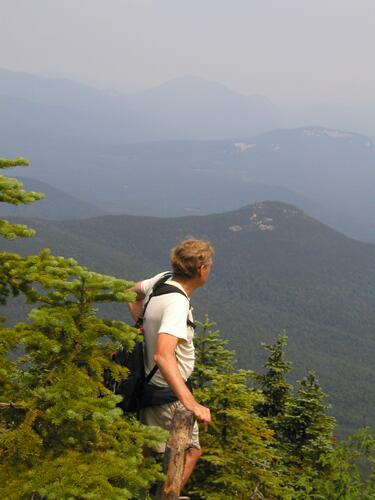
xmin=4 ymin=202 xmax=375 ymax=431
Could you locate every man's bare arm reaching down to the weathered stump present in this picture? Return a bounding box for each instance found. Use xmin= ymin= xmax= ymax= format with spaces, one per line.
xmin=154 ymin=333 xmax=211 ymax=424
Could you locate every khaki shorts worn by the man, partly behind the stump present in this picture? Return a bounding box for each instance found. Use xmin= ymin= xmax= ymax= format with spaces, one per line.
xmin=140 ymin=401 xmax=200 ymax=453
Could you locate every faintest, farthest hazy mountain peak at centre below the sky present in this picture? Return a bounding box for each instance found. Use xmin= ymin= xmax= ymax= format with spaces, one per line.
xmin=129 ymin=77 xmax=282 ymax=140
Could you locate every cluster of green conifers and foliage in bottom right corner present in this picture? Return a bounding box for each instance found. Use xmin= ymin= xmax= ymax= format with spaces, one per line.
xmin=253 ymin=335 xmax=375 ymax=500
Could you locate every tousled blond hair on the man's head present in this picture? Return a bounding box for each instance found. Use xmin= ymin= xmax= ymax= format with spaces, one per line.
xmin=170 ymin=238 xmax=214 ymax=279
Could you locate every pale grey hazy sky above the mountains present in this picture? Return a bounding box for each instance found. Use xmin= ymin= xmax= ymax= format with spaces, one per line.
xmin=0 ymin=0 xmax=375 ymax=105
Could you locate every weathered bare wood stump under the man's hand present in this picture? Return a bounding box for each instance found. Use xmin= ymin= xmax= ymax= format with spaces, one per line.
xmin=155 ymin=409 xmax=195 ymax=500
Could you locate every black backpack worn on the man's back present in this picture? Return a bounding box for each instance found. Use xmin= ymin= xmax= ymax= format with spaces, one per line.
xmin=104 ymin=272 xmax=195 ymax=412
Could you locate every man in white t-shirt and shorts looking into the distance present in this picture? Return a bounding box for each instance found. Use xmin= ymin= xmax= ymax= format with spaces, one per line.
xmin=129 ymin=239 xmax=213 ymax=487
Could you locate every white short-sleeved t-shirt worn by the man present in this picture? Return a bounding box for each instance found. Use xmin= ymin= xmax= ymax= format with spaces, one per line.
xmin=141 ymin=273 xmax=195 ymax=387
